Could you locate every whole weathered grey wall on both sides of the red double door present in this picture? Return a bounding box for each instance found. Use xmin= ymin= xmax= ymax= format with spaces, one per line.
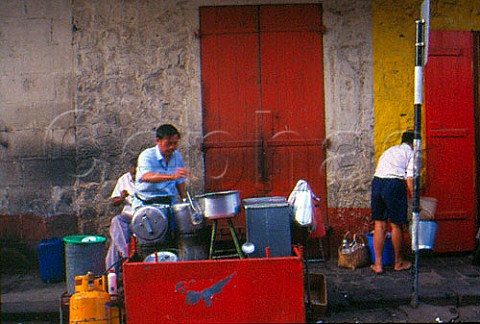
xmin=0 ymin=0 xmax=373 ymax=234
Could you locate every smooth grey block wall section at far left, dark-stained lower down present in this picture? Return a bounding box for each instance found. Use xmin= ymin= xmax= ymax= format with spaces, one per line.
xmin=0 ymin=0 xmax=76 ymax=216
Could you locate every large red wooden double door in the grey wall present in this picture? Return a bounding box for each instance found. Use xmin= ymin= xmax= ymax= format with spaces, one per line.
xmin=200 ymin=5 xmax=326 ymax=228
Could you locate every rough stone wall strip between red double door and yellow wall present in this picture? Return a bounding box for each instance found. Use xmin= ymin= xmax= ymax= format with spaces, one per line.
xmin=323 ymin=1 xmax=375 ymax=208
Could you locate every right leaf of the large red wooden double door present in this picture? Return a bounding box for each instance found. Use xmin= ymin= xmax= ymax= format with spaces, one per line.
xmin=260 ymin=5 xmax=325 ymax=198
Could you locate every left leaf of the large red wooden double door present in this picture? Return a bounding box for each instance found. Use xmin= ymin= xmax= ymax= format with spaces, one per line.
xmin=201 ymin=7 xmax=260 ymax=195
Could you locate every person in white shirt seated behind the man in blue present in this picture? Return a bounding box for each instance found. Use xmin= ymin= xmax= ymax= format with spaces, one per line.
xmin=105 ymin=159 xmax=137 ymax=273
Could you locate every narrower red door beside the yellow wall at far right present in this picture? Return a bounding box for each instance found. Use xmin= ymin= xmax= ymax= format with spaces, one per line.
xmin=425 ymin=31 xmax=477 ymax=253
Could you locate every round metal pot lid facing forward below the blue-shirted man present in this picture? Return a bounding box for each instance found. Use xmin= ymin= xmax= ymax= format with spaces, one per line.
xmin=131 ymin=205 xmax=168 ymax=243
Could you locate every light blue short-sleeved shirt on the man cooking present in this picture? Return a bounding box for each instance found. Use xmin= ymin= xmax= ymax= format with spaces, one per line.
xmin=132 ymin=146 xmax=185 ymax=210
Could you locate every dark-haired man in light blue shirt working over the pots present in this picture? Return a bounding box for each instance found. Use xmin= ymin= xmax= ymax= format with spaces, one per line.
xmin=133 ymin=124 xmax=189 ymax=210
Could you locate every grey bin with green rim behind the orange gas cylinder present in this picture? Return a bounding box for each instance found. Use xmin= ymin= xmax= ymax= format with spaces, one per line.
xmin=63 ymin=235 xmax=106 ymax=295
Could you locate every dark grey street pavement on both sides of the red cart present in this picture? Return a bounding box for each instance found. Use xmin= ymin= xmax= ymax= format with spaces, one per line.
xmin=1 ymin=254 xmax=480 ymax=323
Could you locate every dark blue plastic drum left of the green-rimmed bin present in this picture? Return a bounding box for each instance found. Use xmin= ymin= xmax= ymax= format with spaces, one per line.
xmin=38 ymin=237 xmax=65 ymax=283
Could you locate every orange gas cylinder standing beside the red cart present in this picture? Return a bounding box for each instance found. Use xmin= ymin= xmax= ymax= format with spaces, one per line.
xmin=69 ymin=272 xmax=119 ymax=324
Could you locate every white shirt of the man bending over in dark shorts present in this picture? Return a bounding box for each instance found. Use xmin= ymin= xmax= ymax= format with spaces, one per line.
xmin=375 ymin=143 xmax=413 ymax=180
